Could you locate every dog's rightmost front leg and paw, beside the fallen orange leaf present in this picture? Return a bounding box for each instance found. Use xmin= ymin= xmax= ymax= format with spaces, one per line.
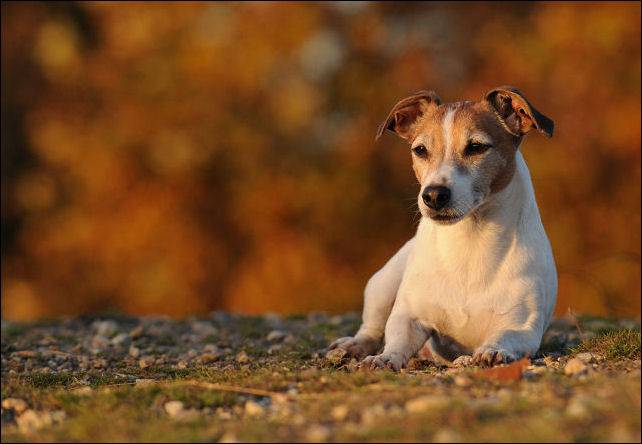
xmin=473 ymin=328 xmax=542 ymax=366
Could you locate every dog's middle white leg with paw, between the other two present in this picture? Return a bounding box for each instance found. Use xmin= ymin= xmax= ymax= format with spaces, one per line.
xmin=361 ymin=309 xmax=434 ymax=371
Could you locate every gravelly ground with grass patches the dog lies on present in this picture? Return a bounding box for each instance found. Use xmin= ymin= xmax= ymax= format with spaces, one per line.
xmin=2 ymin=312 xmax=640 ymax=442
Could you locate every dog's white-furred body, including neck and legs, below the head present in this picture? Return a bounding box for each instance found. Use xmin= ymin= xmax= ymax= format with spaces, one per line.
xmin=333 ymin=151 xmax=557 ymax=370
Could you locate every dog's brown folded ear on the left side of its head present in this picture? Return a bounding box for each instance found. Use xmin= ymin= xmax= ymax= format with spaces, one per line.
xmin=375 ymin=91 xmax=441 ymax=140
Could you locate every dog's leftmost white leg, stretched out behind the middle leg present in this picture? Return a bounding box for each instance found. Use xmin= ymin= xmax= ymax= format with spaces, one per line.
xmin=329 ymin=237 xmax=415 ymax=359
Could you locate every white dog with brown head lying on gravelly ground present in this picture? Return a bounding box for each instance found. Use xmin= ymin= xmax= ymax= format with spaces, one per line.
xmin=329 ymin=86 xmax=557 ymax=371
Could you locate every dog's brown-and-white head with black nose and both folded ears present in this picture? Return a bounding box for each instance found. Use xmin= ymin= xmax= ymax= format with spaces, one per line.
xmin=377 ymin=86 xmax=553 ymax=224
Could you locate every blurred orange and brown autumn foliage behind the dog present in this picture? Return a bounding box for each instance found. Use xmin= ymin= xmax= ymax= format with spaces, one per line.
xmin=1 ymin=2 xmax=640 ymax=319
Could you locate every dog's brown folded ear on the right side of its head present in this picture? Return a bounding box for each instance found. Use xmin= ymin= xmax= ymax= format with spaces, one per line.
xmin=484 ymin=86 xmax=554 ymax=137
